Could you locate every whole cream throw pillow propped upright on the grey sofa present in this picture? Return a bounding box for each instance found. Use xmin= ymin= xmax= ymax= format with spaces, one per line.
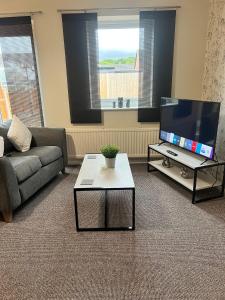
xmin=7 ymin=115 xmax=32 ymax=152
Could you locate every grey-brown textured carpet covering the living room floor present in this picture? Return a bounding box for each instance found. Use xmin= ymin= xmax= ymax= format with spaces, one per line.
xmin=0 ymin=165 xmax=225 ymax=300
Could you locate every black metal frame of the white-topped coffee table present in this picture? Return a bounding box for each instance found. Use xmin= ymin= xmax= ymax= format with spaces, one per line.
xmin=74 ymin=188 xmax=135 ymax=231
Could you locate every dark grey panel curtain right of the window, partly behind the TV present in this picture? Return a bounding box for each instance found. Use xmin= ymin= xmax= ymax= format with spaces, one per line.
xmin=138 ymin=11 xmax=176 ymax=122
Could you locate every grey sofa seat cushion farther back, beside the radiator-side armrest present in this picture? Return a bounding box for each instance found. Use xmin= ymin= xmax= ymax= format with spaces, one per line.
xmin=12 ymin=146 xmax=62 ymax=166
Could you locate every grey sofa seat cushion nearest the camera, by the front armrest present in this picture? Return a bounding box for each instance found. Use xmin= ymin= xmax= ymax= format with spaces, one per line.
xmin=9 ymin=156 xmax=42 ymax=183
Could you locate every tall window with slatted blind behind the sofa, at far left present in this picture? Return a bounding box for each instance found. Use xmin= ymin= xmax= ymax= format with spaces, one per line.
xmin=0 ymin=17 xmax=43 ymax=126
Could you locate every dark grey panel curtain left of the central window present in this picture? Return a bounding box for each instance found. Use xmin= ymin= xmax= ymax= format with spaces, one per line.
xmin=62 ymin=13 xmax=101 ymax=123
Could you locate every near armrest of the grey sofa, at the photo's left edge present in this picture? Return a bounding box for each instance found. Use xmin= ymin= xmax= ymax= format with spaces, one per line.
xmin=0 ymin=156 xmax=21 ymax=222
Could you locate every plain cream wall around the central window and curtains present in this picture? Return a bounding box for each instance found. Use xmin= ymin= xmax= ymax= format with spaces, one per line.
xmin=0 ymin=0 xmax=209 ymax=128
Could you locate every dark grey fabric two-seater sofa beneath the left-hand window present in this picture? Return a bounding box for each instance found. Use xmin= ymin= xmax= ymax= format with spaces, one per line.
xmin=0 ymin=127 xmax=67 ymax=222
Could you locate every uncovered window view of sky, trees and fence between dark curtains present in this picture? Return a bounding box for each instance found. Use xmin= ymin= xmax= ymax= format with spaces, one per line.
xmin=98 ymin=28 xmax=139 ymax=108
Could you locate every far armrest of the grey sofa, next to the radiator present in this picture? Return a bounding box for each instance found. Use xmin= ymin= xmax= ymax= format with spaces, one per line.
xmin=29 ymin=127 xmax=68 ymax=168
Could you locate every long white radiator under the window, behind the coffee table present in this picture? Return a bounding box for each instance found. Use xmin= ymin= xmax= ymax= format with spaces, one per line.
xmin=66 ymin=128 xmax=159 ymax=161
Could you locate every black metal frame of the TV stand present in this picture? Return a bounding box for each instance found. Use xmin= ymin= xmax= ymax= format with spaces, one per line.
xmin=147 ymin=145 xmax=225 ymax=204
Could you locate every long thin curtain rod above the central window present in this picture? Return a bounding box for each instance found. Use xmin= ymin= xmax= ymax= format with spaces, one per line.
xmin=57 ymin=6 xmax=181 ymax=13
